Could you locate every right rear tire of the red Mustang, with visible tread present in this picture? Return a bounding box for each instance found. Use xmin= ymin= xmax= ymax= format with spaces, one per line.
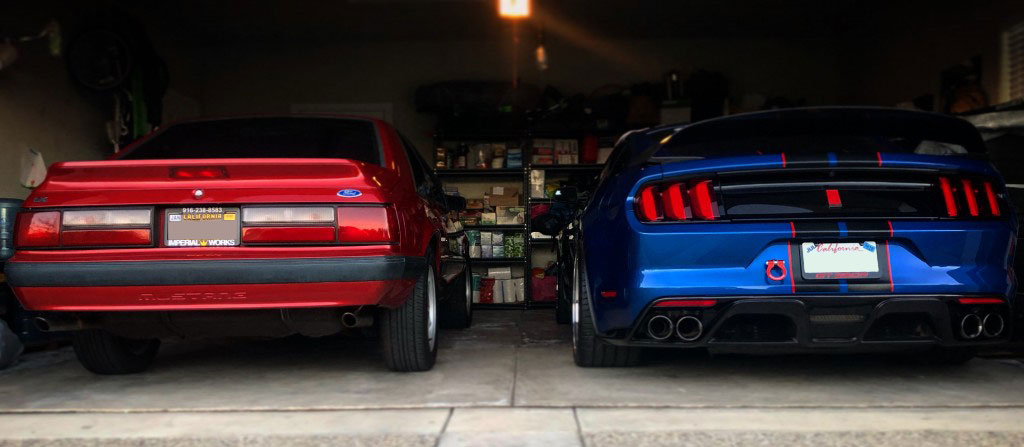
xmin=380 ymin=255 xmax=439 ymax=372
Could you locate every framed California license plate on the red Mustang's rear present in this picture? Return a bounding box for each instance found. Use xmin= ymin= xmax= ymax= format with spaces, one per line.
xmin=164 ymin=207 xmax=242 ymax=248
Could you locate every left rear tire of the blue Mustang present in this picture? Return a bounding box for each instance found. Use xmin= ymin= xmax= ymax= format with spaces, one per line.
xmin=572 ymin=252 xmax=643 ymax=367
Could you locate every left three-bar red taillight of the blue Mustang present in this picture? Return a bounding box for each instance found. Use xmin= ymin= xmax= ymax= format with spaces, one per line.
xmin=635 ymin=179 xmax=719 ymax=222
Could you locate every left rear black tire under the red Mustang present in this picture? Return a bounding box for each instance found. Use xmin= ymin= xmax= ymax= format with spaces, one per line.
xmin=73 ymin=329 xmax=160 ymax=375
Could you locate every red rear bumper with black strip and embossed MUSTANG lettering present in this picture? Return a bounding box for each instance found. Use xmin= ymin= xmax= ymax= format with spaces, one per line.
xmin=6 ymin=256 xmax=427 ymax=312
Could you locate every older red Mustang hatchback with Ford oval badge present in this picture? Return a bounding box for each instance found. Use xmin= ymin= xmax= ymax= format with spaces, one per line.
xmin=6 ymin=117 xmax=472 ymax=373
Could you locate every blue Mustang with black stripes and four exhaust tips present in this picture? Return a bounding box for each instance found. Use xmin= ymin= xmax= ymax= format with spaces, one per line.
xmin=566 ymin=107 xmax=1017 ymax=366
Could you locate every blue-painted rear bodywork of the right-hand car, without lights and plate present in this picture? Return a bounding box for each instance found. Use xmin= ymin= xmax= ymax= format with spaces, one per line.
xmin=583 ymin=153 xmax=1017 ymax=332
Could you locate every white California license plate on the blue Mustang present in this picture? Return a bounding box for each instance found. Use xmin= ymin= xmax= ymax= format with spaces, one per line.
xmin=800 ymin=240 xmax=881 ymax=279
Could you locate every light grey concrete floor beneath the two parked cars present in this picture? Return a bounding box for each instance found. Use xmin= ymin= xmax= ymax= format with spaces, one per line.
xmin=0 ymin=311 xmax=1024 ymax=446
